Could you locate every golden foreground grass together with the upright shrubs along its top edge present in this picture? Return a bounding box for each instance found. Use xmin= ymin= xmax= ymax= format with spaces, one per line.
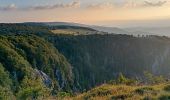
xmin=70 ymin=73 xmax=170 ymax=100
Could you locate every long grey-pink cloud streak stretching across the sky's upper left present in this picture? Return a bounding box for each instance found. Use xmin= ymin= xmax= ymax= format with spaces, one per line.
xmin=0 ymin=0 xmax=80 ymax=11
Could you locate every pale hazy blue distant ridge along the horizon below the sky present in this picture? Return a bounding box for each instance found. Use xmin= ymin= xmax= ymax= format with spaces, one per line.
xmin=25 ymin=22 xmax=170 ymax=36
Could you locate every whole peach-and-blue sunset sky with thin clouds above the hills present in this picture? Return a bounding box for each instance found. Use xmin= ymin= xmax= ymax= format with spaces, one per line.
xmin=0 ymin=0 xmax=170 ymax=27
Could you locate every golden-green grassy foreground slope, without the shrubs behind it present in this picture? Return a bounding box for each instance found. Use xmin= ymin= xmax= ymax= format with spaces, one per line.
xmin=70 ymin=83 xmax=170 ymax=100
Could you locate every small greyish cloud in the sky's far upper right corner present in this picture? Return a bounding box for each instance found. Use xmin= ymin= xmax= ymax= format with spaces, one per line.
xmin=144 ymin=1 xmax=167 ymax=7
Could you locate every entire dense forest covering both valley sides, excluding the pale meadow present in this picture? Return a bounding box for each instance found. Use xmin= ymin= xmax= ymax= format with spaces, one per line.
xmin=0 ymin=23 xmax=170 ymax=100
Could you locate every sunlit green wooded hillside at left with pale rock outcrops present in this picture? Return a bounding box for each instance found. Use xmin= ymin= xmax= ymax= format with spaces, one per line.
xmin=0 ymin=35 xmax=73 ymax=100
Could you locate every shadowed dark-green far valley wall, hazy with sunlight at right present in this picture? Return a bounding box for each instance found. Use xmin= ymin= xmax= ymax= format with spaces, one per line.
xmin=49 ymin=35 xmax=170 ymax=89
